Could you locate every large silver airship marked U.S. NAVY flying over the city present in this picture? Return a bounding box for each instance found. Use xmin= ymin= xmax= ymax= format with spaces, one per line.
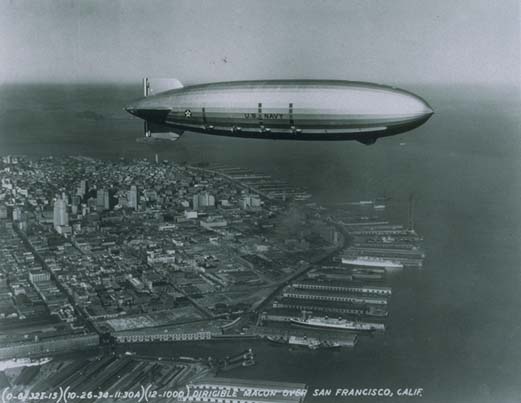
xmin=125 ymin=78 xmax=433 ymax=144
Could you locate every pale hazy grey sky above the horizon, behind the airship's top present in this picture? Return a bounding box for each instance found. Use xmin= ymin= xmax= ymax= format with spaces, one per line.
xmin=0 ymin=0 xmax=521 ymax=84
